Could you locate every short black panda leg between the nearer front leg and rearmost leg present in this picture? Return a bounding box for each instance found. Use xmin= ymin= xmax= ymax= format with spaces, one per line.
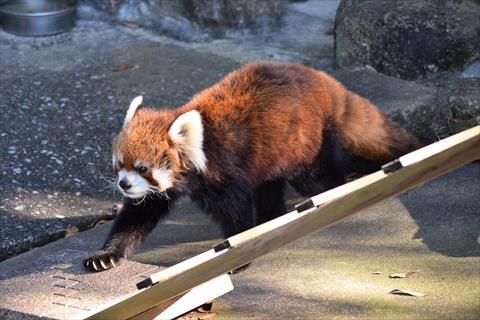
xmin=254 ymin=179 xmax=287 ymax=224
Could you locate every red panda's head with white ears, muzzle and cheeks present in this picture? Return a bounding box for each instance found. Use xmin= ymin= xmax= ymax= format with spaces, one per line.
xmin=112 ymin=97 xmax=206 ymax=199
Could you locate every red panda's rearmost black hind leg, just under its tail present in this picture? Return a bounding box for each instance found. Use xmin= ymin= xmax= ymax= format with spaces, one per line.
xmin=288 ymin=128 xmax=346 ymax=197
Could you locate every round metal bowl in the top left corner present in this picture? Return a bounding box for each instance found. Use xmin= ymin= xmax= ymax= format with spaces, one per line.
xmin=0 ymin=0 xmax=76 ymax=36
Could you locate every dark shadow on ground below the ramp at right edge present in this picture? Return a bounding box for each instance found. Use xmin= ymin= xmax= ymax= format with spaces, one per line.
xmin=399 ymin=162 xmax=480 ymax=257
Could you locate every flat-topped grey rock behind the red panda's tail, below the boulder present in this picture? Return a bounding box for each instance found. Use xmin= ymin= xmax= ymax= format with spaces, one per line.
xmin=333 ymin=68 xmax=480 ymax=143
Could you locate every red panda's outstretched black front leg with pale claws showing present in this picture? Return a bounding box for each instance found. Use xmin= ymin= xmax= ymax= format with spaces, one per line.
xmin=83 ymin=195 xmax=173 ymax=271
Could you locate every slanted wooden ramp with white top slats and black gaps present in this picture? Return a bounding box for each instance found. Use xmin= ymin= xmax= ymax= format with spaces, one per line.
xmin=88 ymin=126 xmax=480 ymax=319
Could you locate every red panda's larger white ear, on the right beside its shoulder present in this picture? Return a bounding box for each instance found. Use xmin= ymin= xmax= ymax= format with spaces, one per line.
xmin=168 ymin=110 xmax=207 ymax=171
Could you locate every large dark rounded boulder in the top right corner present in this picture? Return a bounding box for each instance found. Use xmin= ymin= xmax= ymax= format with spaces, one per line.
xmin=335 ymin=0 xmax=480 ymax=79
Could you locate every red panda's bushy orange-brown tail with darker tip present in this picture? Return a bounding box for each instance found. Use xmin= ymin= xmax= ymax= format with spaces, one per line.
xmin=336 ymin=90 xmax=422 ymax=163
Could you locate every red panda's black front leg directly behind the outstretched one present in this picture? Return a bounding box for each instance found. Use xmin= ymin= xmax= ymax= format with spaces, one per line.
xmin=191 ymin=177 xmax=255 ymax=238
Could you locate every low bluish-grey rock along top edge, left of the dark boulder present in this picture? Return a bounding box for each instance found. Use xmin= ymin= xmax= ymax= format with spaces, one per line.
xmin=80 ymin=0 xmax=287 ymax=40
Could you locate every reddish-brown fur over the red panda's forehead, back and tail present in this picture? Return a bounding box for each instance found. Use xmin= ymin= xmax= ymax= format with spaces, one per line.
xmin=114 ymin=62 xmax=419 ymax=185
